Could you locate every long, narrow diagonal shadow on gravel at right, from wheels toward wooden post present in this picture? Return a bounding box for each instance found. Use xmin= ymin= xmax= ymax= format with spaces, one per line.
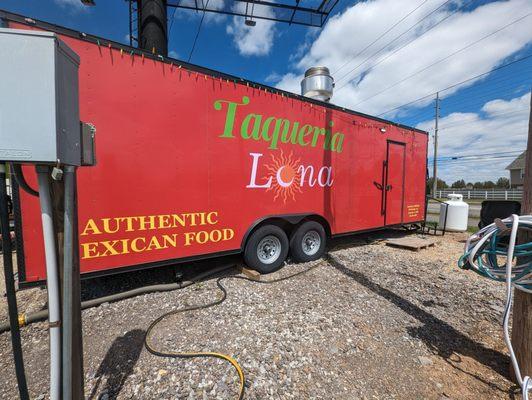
xmin=327 ymin=255 xmax=510 ymax=385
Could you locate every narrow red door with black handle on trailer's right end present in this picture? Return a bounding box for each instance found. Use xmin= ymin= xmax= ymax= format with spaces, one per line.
xmin=384 ymin=140 xmax=405 ymax=225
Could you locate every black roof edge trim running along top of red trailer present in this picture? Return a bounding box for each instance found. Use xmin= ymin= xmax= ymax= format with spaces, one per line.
xmin=0 ymin=9 xmax=428 ymax=135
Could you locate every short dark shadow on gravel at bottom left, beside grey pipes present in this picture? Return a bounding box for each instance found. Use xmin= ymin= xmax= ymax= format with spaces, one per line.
xmin=89 ymin=329 xmax=146 ymax=400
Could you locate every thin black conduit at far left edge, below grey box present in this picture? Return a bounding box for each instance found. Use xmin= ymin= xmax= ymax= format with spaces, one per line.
xmin=0 ymin=164 xmax=30 ymax=400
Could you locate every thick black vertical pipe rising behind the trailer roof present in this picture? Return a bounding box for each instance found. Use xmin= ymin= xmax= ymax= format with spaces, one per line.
xmin=137 ymin=0 xmax=168 ymax=57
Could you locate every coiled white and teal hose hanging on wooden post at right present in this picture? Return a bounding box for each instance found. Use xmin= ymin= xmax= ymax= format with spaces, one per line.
xmin=458 ymin=214 xmax=532 ymax=400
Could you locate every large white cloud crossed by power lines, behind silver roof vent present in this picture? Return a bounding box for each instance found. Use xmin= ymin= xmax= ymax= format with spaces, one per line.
xmin=277 ymin=0 xmax=532 ymax=117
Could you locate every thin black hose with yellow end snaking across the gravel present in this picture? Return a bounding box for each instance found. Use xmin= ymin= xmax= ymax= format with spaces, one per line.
xmin=144 ymin=263 xmax=323 ymax=400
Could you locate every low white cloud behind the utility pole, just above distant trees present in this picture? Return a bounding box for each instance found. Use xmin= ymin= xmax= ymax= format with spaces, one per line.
xmin=417 ymin=93 xmax=530 ymax=183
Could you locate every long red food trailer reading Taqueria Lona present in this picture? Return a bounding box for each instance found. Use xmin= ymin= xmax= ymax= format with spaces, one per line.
xmin=0 ymin=13 xmax=428 ymax=285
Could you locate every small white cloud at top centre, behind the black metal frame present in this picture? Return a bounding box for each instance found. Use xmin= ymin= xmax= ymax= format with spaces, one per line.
xmin=226 ymin=3 xmax=275 ymax=56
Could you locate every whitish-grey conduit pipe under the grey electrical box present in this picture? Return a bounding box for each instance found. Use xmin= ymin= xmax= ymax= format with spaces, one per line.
xmin=36 ymin=165 xmax=61 ymax=400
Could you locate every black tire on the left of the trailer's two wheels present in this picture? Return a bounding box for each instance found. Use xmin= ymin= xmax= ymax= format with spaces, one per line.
xmin=244 ymin=225 xmax=290 ymax=274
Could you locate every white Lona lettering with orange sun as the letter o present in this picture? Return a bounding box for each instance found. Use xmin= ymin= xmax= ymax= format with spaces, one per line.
xmin=246 ymin=151 xmax=334 ymax=204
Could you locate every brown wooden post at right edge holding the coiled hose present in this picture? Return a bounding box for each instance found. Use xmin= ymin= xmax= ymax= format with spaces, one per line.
xmin=512 ymin=91 xmax=532 ymax=382
